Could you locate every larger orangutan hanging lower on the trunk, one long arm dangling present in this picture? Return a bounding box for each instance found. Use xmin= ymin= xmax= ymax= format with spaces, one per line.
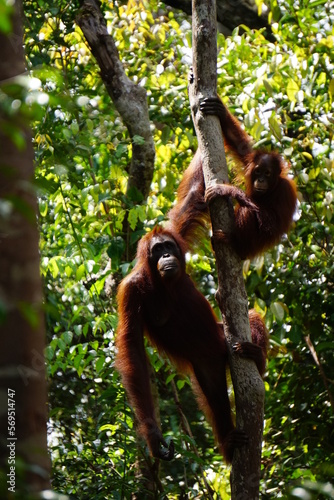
xmin=116 ymin=228 xmax=267 ymax=462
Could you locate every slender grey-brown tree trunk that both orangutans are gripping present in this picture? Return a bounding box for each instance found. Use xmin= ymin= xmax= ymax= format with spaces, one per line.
xmin=189 ymin=0 xmax=264 ymax=500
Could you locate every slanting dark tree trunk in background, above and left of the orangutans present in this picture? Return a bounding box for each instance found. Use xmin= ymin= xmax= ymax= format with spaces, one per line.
xmin=77 ymin=0 xmax=155 ymax=199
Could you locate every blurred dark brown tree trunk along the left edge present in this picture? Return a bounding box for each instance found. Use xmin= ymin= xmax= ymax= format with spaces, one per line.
xmin=0 ymin=1 xmax=49 ymax=492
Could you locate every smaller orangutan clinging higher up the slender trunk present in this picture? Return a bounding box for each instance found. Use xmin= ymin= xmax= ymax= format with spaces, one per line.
xmin=169 ymin=97 xmax=297 ymax=259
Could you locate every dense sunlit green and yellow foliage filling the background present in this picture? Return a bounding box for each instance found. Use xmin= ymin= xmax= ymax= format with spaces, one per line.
xmin=19 ymin=0 xmax=334 ymax=499
